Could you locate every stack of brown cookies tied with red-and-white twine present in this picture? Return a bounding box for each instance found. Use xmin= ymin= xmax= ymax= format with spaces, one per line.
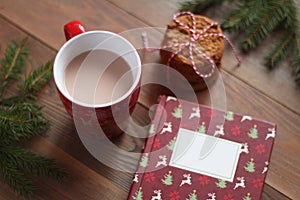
xmin=160 ymin=15 xmax=224 ymax=91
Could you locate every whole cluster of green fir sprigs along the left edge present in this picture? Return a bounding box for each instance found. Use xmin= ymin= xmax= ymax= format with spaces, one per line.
xmin=0 ymin=39 xmax=67 ymax=198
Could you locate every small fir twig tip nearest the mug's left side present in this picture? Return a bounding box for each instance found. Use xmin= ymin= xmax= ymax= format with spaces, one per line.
xmin=19 ymin=61 xmax=52 ymax=98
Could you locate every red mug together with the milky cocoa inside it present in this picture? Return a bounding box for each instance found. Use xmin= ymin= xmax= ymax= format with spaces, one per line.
xmin=53 ymin=21 xmax=141 ymax=138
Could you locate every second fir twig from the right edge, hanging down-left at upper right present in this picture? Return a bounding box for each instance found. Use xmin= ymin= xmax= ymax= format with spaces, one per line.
xmin=265 ymin=32 xmax=295 ymax=69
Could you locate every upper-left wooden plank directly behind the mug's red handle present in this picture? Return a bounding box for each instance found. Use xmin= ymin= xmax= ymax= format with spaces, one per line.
xmin=0 ymin=0 xmax=149 ymax=50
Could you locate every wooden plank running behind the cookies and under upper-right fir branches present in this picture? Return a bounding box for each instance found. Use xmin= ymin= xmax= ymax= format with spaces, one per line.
xmin=109 ymin=0 xmax=300 ymax=114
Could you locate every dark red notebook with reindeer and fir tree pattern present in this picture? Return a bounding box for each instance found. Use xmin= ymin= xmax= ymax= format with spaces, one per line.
xmin=128 ymin=96 xmax=276 ymax=200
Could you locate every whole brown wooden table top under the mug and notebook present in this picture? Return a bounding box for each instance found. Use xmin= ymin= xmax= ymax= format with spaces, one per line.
xmin=0 ymin=0 xmax=300 ymax=200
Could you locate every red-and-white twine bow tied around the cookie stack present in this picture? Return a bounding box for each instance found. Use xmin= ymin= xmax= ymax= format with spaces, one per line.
xmin=142 ymin=11 xmax=241 ymax=78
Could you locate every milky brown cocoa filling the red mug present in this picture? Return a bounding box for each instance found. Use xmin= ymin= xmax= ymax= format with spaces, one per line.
xmin=65 ymin=50 xmax=133 ymax=104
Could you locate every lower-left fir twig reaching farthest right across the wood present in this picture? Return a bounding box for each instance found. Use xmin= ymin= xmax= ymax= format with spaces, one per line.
xmin=1 ymin=146 xmax=68 ymax=182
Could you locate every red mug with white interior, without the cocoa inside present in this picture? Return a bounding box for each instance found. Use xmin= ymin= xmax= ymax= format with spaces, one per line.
xmin=53 ymin=21 xmax=141 ymax=138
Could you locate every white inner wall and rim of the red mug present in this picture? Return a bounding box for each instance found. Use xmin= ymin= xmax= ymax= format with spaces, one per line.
xmin=53 ymin=31 xmax=141 ymax=107
